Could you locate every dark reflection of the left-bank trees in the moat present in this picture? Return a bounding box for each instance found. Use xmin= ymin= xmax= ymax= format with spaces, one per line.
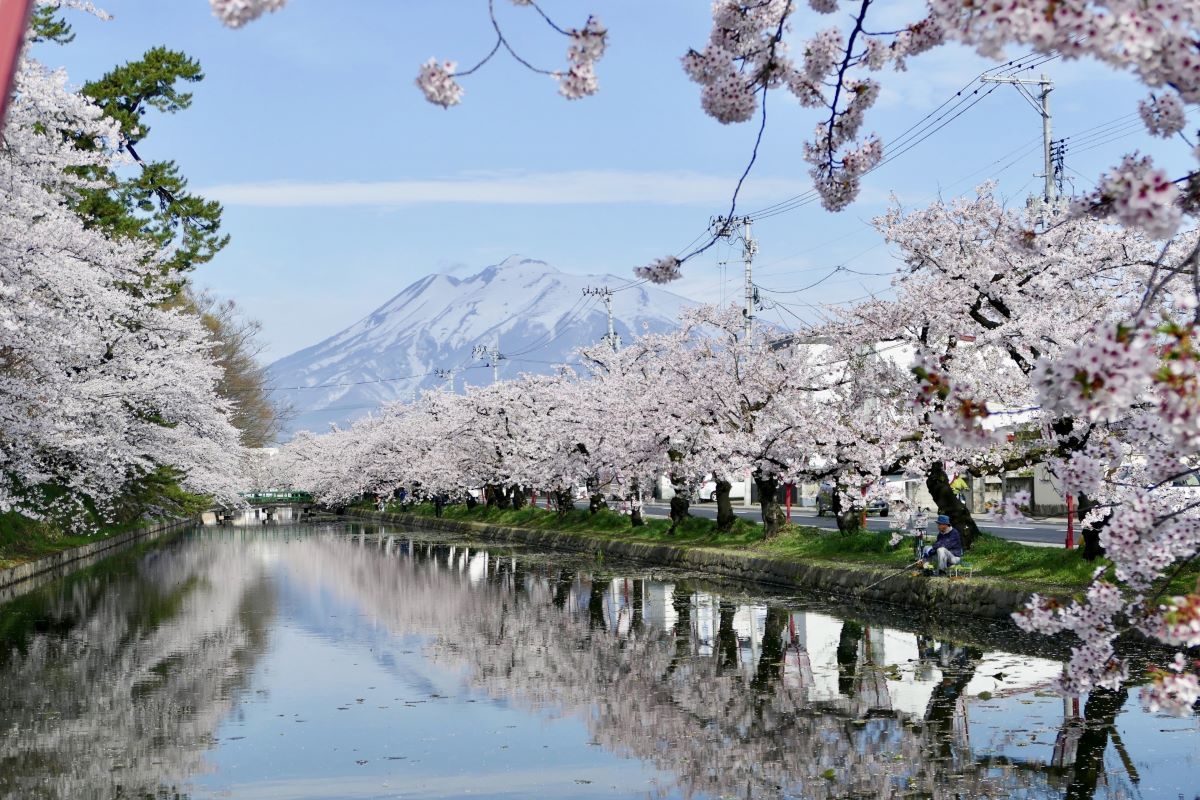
xmin=0 ymin=541 xmax=274 ymax=800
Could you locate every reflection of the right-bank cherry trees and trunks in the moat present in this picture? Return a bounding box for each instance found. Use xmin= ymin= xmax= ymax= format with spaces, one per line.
xmin=274 ymin=536 xmax=1089 ymax=798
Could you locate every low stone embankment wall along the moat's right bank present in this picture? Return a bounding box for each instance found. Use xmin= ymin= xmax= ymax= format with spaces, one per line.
xmin=354 ymin=513 xmax=1060 ymax=620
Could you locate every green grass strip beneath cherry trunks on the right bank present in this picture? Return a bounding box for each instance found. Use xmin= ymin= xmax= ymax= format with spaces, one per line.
xmin=361 ymin=504 xmax=1108 ymax=593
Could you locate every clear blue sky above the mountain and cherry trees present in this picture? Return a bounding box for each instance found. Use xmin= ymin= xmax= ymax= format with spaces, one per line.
xmin=37 ymin=0 xmax=1188 ymax=359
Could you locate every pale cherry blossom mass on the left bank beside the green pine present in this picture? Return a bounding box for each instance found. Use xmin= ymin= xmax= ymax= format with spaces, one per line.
xmin=0 ymin=51 xmax=241 ymax=521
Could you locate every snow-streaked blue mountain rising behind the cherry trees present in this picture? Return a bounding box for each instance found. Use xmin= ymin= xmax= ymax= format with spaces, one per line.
xmin=269 ymin=255 xmax=691 ymax=434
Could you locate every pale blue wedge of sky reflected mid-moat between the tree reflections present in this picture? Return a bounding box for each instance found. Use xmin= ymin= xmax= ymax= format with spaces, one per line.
xmin=193 ymin=561 xmax=670 ymax=799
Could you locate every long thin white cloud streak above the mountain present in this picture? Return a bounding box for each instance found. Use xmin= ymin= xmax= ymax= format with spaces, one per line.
xmin=200 ymin=170 xmax=809 ymax=207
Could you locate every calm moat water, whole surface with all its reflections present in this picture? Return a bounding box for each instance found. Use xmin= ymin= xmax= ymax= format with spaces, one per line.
xmin=0 ymin=524 xmax=1200 ymax=800
